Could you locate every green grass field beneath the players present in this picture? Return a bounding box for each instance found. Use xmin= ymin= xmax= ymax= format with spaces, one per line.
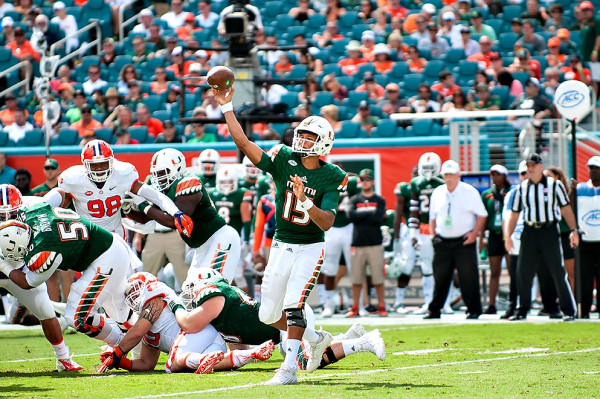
xmin=0 ymin=322 xmax=600 ymax=398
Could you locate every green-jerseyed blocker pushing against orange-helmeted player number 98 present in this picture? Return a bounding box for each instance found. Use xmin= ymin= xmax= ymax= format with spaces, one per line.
xmin=128 ymin=148 xmax=240 ymax=281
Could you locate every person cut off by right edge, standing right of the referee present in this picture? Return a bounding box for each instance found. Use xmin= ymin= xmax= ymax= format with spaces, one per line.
xmin=577 ymin=155 xmax=600 ymax=319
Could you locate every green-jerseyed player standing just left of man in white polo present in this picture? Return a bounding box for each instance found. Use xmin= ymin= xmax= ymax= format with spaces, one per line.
xmin=399 ymin=152 xmax=444 ymax=314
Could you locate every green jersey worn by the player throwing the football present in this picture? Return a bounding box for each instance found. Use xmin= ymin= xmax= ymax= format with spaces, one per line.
xmin=256 ymin=144 xmax=348 ymax=244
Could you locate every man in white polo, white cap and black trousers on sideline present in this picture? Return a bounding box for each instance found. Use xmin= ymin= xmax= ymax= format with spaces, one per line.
xmin=424 ymin=160 xmax=487 ymax=319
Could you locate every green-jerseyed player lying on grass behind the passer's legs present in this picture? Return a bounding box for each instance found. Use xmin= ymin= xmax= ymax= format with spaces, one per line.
xmin=173 ymin=269 xmax=385 ymax=376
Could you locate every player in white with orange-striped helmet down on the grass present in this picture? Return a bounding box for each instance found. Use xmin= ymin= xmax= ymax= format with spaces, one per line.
xmin=98 ymin=272 xmax=275 ymax=374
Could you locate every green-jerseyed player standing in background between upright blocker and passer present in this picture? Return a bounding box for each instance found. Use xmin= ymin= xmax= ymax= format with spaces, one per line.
xmin=209 ymin=165 xmax=252 ymax=292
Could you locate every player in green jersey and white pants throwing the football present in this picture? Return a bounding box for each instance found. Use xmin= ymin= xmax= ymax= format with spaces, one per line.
xmin=213 ymin=88 xmax=347 ymax=385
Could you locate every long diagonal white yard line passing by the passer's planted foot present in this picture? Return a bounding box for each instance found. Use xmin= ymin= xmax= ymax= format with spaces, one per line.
xmin=120 ymin=348 xmax=600 ymax=399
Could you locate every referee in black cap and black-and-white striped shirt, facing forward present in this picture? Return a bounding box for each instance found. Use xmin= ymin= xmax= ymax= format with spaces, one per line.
xmin=504 ymin=154 xmax=579 ymax=321
